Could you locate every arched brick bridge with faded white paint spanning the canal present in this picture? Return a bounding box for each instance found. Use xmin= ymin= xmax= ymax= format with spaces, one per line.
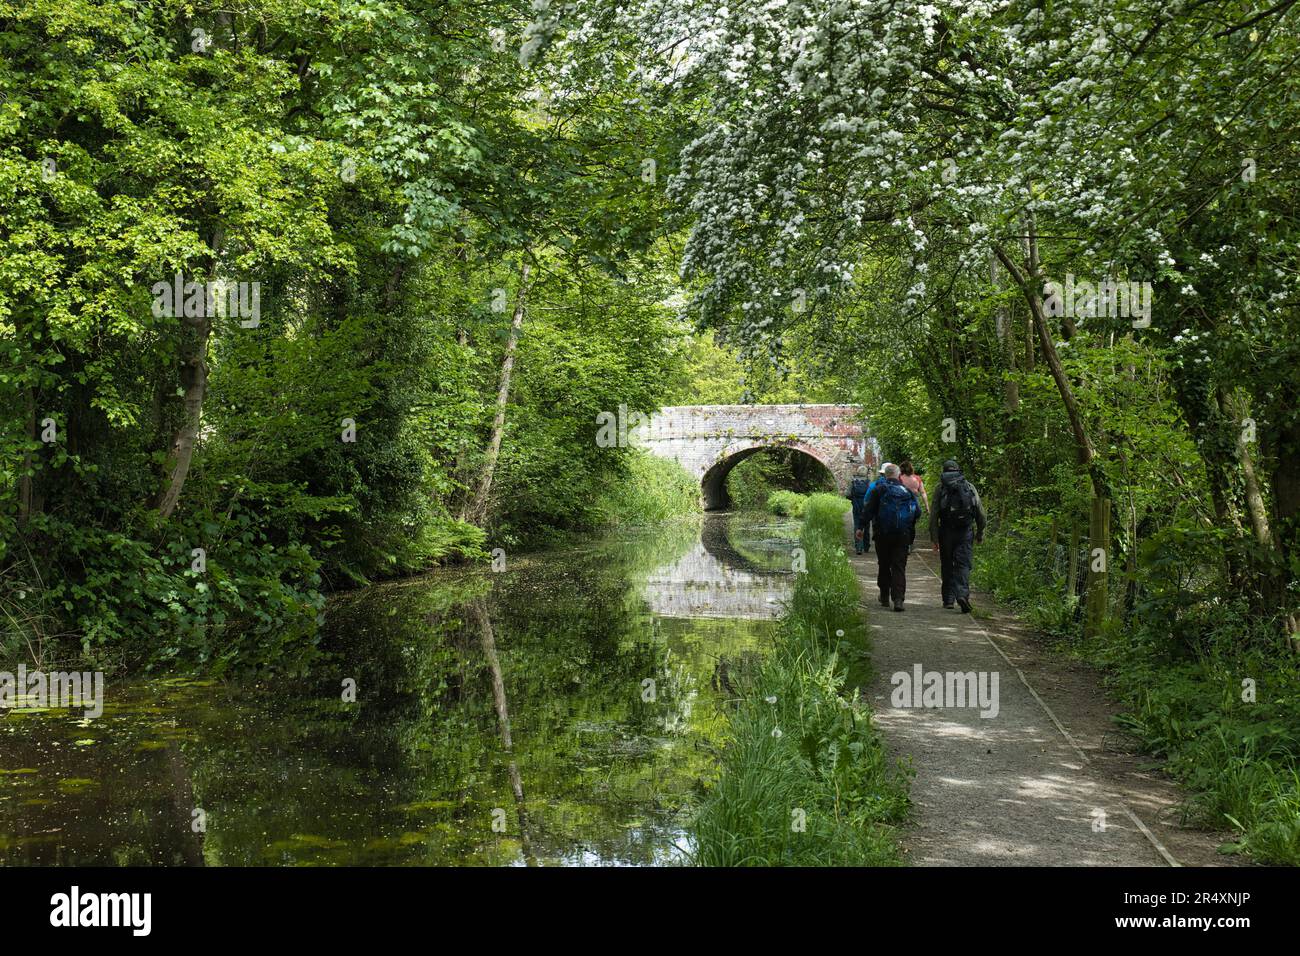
xmin=640 ymin=405 xmax=880 ymax=509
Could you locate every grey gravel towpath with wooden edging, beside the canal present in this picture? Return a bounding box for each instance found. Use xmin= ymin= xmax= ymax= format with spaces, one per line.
xmin=849 ymin=515 xmax=1235 ymax=866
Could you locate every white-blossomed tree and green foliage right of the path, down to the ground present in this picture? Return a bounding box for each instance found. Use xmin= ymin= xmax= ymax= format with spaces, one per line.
xmin=660 ymin=0 xmax=1300 ymax=861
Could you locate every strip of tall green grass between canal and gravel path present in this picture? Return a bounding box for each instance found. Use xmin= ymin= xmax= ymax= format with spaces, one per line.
xmin=694 ymin=494 xmax=909 ymax=866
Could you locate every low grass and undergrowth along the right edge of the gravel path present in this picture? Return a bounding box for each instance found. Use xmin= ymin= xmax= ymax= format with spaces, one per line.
xmin=975 ymin=520 xmax=1300 ymax=865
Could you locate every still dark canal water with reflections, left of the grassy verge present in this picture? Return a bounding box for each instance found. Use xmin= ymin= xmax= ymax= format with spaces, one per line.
xmin=0 ymin=514 xmax=798 ymax=866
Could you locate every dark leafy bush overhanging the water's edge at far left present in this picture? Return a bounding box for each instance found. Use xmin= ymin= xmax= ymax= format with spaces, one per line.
xmin=0 ymin=509 xmax=325 ymax=674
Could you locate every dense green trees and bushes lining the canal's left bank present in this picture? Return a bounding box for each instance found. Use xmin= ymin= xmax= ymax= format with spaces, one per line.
xmin=0 ymin=0 xmax=686 ymax=670
